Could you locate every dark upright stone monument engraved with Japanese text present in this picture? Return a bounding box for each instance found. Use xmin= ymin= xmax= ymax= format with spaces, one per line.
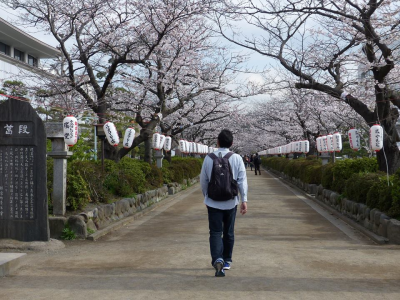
xmin=0 ymin=99 xmax=50 ymax=242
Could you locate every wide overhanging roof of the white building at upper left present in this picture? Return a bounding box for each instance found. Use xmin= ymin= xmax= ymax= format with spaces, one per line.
xmin=0 ymin=17 xmax=61 ymax=58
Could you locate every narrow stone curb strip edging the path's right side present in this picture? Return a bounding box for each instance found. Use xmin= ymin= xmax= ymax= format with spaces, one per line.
xmin=264 ymin=169 xmax=389 ymax=245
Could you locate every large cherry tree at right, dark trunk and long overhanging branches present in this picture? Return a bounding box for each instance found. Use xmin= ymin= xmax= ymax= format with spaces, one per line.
xmin=216 ymin=0 xmax=400 ymax=173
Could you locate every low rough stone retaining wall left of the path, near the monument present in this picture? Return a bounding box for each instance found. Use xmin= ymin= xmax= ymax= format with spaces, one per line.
xmin=49 ymin=176 xmax=199 ymax=239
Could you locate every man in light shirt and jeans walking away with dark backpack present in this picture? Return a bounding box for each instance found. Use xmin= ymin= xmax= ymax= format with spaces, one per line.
xmin=200 ymin=129 xmax=247 ymax=277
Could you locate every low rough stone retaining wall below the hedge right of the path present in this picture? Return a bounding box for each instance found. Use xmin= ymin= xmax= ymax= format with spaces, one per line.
xmin=269 ymin=169 xmax=400 ymax=244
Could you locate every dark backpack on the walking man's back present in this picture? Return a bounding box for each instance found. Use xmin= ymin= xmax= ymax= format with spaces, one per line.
xmin=207 ymin=152 xmax=239 ymax=201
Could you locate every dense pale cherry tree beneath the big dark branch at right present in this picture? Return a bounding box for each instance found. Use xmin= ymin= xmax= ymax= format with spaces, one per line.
xmin=244 ymin=85 xmax=367 ymax=154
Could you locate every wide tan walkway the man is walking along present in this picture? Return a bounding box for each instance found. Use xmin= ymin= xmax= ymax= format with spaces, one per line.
xmin=0 ymin=170 xmax=400 ymax=300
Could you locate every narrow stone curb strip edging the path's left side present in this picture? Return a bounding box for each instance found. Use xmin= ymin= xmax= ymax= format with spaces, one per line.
xmin=87 ymin=184 xmax=197 ymax=241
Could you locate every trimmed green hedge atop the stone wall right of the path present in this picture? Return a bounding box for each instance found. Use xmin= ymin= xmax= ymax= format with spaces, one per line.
xmin=262 ymin=157 xmax=400 ymax=218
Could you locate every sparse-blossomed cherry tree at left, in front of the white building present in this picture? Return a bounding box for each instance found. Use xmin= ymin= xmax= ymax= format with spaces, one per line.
xmin=3 ymin=0 xmax=223 ymax=159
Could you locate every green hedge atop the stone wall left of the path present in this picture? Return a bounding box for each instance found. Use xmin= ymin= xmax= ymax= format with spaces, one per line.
xmin=47 ymin=158 xmax=202 ymax=212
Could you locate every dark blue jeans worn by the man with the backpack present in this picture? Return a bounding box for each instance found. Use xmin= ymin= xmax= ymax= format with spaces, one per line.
xmin=207 ymin=206 xmax=237 ymax=265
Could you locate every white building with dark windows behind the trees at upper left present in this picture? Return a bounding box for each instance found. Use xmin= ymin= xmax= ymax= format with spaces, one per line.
xmin=0 ymin=18 xmax=61 ymax=82
